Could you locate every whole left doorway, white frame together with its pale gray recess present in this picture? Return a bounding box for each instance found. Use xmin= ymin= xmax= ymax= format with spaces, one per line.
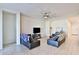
xmin=0 ymin=9 xmax=20 ymax=49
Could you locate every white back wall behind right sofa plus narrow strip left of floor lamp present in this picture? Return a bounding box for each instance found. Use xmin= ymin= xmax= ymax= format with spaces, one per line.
xmin=45 ymin=18 xmax=67 ymax=36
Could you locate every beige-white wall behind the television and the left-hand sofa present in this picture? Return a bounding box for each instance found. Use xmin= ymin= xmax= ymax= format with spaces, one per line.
xmin=21 ymin=15 xmax=41 ymax=34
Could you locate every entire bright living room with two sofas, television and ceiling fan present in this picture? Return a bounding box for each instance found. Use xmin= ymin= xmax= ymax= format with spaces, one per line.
xmin=0 ymin=3 xmax=79 ymax=55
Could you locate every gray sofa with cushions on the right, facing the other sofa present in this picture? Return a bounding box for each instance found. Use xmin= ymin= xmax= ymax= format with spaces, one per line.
xmin=47 ymin=32 xmax=65 ymax=47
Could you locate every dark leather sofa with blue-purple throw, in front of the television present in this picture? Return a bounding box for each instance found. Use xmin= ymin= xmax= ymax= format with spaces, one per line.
xmin=20 ymin=34 xmax=40 ymax=49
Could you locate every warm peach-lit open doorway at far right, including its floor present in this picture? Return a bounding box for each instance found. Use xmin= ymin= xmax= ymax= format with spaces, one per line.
xmin=68 ymin=16 xmax=79 ymax=50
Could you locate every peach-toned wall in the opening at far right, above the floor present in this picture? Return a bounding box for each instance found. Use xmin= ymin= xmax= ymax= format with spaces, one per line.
xmin=69 ymin=16 xmax=79 ymax=37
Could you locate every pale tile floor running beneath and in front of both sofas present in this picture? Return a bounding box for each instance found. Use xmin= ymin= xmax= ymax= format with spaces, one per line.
xmin=0 ymin=38 xmax=79 ymax=55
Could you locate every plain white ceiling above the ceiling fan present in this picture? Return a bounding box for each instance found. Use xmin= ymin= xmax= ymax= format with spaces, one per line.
xmin=0 ymin=3 xmax=79 ymax=17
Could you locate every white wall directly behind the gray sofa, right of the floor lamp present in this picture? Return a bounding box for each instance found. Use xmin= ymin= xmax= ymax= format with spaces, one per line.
xmin=51 ymin=18 xmax=67 ymax=33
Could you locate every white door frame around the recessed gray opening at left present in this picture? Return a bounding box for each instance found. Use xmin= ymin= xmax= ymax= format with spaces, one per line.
xmin=0 ymin=9 xmax=20 ymax=49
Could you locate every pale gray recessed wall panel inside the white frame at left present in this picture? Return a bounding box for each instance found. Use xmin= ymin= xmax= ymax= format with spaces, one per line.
xmin=3 ymin=12 xmax=16 ymax=45
